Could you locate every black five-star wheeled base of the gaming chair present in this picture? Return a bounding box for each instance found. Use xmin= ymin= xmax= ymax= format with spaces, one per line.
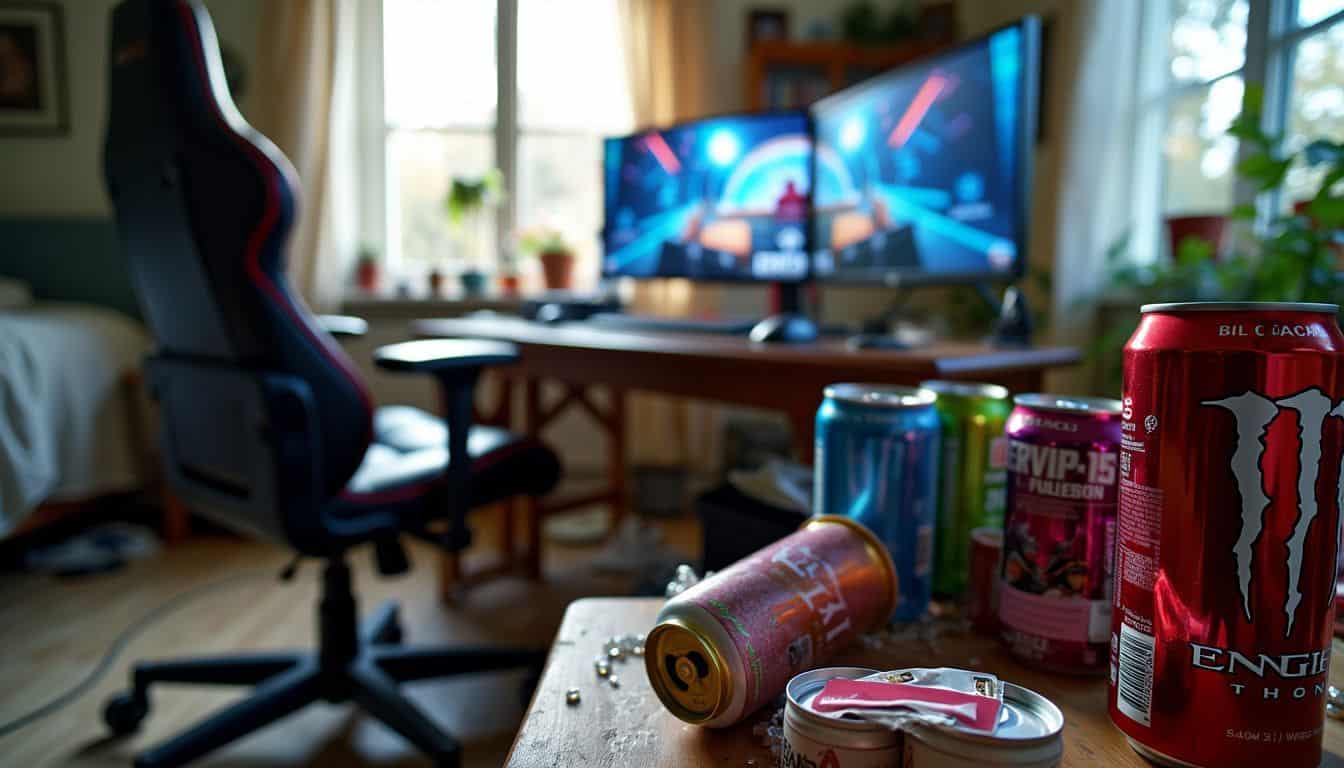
xmin=103 ymin=561 xmax=546 ymax=768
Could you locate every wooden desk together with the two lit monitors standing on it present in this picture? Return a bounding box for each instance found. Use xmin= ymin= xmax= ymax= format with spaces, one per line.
xmin=413 ymin=10 xmax=1079 ymax=599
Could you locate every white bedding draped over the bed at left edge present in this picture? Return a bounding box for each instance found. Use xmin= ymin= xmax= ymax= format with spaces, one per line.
xmin=0 ymin=303 xmax=151 ymax=534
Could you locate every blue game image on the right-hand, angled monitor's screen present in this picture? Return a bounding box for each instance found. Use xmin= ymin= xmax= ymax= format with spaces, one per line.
xmin=810 ymin=20 xmax=1035 ymax=282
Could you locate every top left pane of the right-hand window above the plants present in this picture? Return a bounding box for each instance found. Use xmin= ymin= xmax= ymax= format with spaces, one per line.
xmin=1169 ymin=0 xmax=1247 ymax=82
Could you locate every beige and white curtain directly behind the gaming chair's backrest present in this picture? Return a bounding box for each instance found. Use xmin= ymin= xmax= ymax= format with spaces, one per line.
xmin=251 ymin=0 xmax=358 ymax=309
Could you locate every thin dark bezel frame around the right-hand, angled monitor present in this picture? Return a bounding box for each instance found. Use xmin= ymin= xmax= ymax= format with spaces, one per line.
xmin=808 ymin=13 xmax=1042 ymax=288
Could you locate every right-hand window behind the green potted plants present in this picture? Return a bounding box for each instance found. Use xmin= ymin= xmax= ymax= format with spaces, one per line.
xmin=1136 ymin=0 xmax=1344 ymax=260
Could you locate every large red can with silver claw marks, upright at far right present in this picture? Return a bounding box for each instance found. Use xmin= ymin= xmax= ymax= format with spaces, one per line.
xmin=1109 ymin=303 xmax=1344 ymax=768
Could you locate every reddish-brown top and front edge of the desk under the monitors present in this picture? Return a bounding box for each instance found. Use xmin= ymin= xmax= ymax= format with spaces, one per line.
xmin=411 ymin=315 xmax=1079 ymax=461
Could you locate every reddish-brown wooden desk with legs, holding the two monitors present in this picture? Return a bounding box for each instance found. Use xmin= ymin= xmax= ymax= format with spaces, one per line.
xmin=413 ymin=316 xmax=1079 ymax=580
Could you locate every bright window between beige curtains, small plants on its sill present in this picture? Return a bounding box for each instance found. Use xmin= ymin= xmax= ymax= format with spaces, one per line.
xmin=382 ymin=0 xmax=632 ymax=288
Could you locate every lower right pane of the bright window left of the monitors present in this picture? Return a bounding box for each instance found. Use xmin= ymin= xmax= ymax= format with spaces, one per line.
xmin=517 ymin=133 xmax=602 ymax=288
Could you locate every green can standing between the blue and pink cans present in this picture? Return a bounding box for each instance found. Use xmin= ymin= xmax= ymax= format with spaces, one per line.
xmin=919 ymin=381 xmax=1012 ymax=597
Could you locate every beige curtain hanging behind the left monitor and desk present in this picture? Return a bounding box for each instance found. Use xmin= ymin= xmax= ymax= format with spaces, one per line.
xmin=618 ymin=0 xmax=719 ymax=468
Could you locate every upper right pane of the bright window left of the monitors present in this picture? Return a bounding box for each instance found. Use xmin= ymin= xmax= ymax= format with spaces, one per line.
xmin=517 ymin=0 xmax=630 ymax=133
